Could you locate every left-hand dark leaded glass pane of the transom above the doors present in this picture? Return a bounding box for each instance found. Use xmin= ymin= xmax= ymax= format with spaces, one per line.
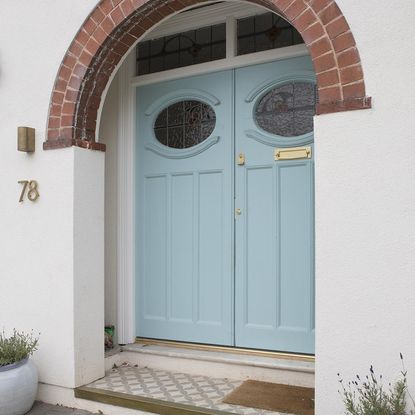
xmin=136 ymin=23 xmax=226 ymax=75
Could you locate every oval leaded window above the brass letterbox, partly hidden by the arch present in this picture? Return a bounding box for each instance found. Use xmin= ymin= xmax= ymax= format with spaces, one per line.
xmin=255 ymin=82 xmax=317 ymax=137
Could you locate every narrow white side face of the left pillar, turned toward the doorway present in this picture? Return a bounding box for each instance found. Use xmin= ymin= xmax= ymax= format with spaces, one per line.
xmin=72 ymin=147 xmax=105 ymax=386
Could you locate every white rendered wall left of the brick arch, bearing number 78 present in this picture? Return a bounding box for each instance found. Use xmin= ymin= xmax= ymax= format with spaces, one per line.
xmin=0 ymin=0 xmax=103 ymax=387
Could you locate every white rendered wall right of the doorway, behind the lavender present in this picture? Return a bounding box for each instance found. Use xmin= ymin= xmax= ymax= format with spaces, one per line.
xmin=315 ymin=0 xmax=415 ymax=415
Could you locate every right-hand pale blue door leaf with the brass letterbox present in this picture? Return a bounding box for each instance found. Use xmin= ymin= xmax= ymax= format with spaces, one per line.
xmin=235 ymin=57 xmax=315 ymax=353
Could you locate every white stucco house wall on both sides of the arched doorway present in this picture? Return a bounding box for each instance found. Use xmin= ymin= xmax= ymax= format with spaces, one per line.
xmin=0 ymin=0 xmax=415 ymax=415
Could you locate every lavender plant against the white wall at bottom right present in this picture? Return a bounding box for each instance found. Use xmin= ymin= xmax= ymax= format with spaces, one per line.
xmin=337 ymin=354 xmax=413 ymax=415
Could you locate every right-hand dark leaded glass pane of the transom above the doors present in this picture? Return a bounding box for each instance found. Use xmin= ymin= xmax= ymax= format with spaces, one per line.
xmin=238 ymin=13 xmax=304 ymax=55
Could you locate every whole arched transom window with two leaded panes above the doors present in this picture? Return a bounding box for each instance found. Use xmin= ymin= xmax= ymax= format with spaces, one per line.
xmin=136 ymin=2 xmax=304 ymax=76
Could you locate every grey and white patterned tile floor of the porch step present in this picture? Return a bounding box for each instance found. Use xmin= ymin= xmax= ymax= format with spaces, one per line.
xmin=87 ymin=366 xmax=290 ymax=415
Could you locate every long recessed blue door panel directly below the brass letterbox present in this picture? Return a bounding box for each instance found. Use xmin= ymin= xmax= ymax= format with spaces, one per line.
xmin=277 ymin=161 xmax=314 ymax=333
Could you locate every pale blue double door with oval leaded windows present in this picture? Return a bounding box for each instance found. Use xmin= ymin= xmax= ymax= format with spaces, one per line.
xmin=136 ymin=57 xmax=314 ymax=354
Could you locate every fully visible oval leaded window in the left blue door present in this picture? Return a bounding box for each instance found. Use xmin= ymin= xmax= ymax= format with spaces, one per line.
xmin=154 ymin=100 xmax=216 ymax=149
